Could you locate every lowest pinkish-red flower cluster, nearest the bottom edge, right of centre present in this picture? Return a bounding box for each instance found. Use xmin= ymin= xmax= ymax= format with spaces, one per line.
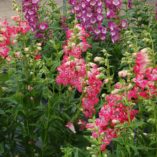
xmin=86 ymin=94 xmax=137 ymax=151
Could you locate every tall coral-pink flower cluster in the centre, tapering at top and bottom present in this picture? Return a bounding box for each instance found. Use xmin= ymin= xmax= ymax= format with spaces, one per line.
xmin=56 ymin=25 xmax=102 ymax=117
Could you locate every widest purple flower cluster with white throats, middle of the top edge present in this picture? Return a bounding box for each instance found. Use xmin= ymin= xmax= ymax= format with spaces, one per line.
xmin=69 ymin=0 xmax=106 ymax=40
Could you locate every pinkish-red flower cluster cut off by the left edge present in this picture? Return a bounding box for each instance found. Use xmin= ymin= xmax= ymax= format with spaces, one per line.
xmin=0 ymin=16 xmax=30 ymax=59
